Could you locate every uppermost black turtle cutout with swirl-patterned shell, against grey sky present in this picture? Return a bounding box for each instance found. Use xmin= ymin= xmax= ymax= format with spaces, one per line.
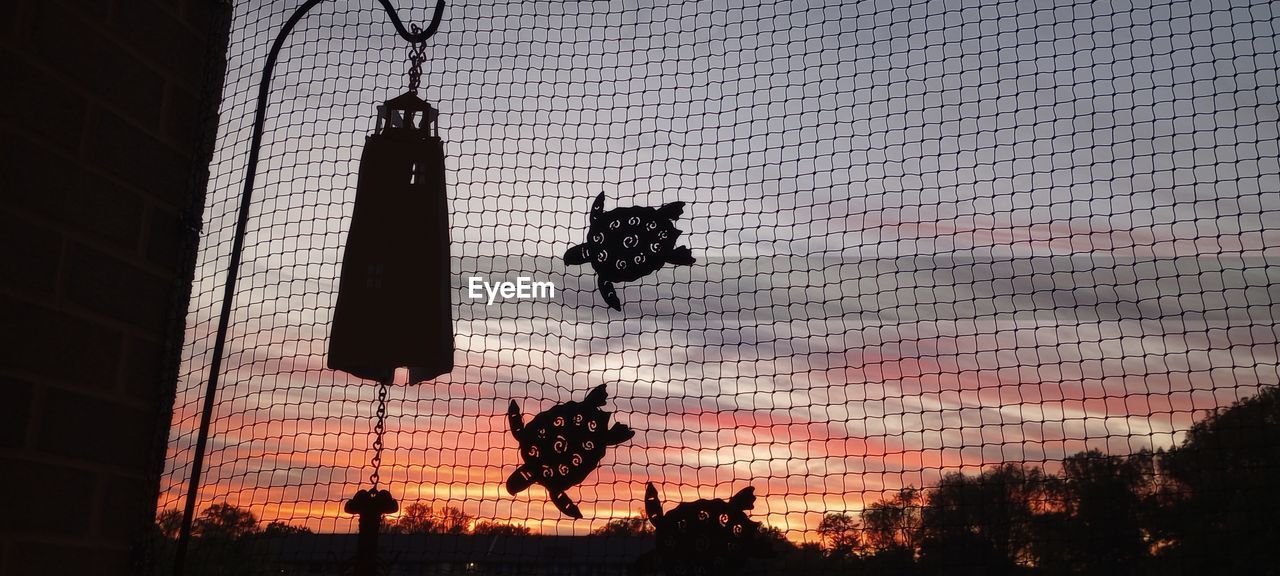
xmin=564 ymin=192 xmax=694 ymax=310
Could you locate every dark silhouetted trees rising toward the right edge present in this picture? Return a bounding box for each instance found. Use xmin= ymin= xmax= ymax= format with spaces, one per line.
xmin=782 ymin=388 xmax=1280 ymax=575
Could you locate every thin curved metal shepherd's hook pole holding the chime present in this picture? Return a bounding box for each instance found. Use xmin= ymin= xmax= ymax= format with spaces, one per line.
xmin=173 ymin=0 xmax=444 ymax=576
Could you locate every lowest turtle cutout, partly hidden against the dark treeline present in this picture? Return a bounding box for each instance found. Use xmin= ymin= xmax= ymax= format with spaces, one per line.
xmin=644 ymin=483 xmax=772 ymax=576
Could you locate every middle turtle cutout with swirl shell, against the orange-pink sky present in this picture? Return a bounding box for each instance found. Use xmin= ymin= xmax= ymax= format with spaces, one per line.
xmin=507 ymin=384 xmax=636 ymax=518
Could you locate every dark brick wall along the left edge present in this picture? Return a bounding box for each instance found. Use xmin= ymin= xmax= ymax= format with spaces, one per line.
xmin=0 ymin=0 xmax=230 ymax=576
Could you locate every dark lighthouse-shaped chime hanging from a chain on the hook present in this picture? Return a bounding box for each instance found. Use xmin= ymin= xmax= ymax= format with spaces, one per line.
xmin=329 ymin=36 xmax=453 ymax=384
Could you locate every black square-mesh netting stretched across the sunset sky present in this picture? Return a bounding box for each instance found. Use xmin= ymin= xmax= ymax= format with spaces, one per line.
xmin=159 ymin=0 xmax=1280 ymax=573
